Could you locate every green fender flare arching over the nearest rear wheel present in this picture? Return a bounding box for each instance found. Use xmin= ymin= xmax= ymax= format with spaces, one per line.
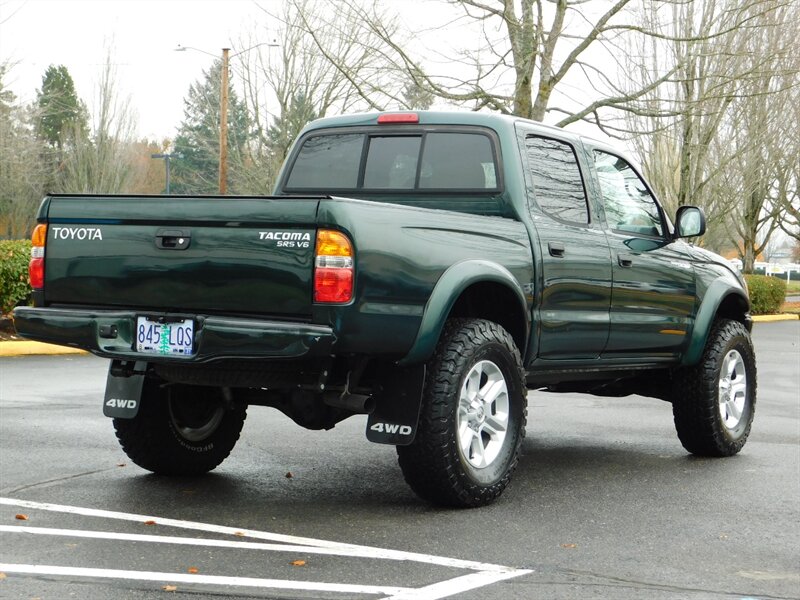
xmin=399 ymin=260 xmax=530 ymax=366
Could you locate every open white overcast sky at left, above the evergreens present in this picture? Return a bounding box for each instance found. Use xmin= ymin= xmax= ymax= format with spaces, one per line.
xmin=0 ymin=0 xmax=278 ymax=140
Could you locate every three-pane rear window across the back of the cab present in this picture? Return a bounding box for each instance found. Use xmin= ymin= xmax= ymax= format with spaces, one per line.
xmin=284 ymin=131 xmax=499 ymax=192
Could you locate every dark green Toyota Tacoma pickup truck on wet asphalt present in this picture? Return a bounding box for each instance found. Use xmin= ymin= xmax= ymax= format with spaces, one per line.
xmin=14 ymin=112 xmax=756 ymax=506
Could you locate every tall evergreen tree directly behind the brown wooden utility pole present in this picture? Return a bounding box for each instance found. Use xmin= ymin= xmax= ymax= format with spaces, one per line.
xmin=171 ymin=60 xmax=250 ymax=194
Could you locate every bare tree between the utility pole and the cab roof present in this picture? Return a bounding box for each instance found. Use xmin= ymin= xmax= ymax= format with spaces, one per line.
xmin=236 ymin=0 xmax=380 ymax=193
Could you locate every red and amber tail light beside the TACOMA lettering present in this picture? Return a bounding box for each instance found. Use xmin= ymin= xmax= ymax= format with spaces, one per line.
xmin=314 ymin=229 xmax=354 ymax=304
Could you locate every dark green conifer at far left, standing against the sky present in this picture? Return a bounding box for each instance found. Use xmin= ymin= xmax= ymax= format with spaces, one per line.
xmin=36 ymin=65 xmax=88 ymax=148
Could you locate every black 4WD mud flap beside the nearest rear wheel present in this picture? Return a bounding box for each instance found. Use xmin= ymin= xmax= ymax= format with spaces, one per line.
xmin=367 ymin=365 xmax=425 ymax=446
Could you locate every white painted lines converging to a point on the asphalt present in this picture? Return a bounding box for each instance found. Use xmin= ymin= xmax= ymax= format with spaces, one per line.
xmin=0 ymin=498 xmax=532 ymax=600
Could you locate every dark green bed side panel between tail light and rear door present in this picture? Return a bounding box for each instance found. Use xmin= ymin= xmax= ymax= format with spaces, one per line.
xmin=313 ymin=198 xmax=533 ymax=357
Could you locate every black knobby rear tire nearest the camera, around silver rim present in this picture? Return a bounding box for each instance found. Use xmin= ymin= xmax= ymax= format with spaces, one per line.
xmin=397 ymin=319 xmax=527 ymax=507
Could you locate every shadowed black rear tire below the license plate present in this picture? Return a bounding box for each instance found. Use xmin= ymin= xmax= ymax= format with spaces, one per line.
xmin=114 ymin=379 xmax=247 ymax=475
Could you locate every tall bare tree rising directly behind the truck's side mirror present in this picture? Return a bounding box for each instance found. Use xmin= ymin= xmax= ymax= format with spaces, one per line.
xmin=624 ymin=0 xmax=777 ymax=249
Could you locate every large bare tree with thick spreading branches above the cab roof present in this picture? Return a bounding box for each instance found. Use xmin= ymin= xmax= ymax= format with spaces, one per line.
xmin=290 ymin=0 xmax=720 ymax=127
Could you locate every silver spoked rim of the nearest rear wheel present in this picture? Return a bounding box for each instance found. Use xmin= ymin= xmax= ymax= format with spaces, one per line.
xmin=457 ymin=360 xmax=509 ymax=469
